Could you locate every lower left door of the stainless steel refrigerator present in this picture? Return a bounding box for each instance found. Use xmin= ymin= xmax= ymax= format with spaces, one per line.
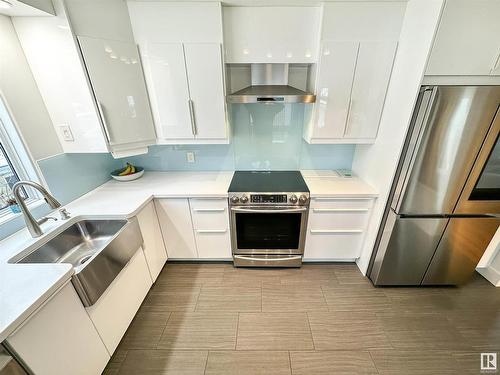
xmin=370 ymin=211 xmax=448 ymax=285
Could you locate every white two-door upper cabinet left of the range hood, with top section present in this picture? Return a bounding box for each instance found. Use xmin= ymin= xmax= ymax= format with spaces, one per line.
xmin=127 ymin=1 xmax=229 ymax=143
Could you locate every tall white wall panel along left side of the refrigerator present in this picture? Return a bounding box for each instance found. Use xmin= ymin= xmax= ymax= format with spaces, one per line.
xmin=352 ymin=0 xmax=444 ymax=274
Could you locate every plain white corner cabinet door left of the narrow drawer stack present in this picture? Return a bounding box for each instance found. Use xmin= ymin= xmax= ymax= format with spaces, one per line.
xmin=155 ymin=198 xmax=198 ymax=259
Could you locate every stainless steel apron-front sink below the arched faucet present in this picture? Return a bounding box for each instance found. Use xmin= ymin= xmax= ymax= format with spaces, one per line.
xmin=9 ymin=218 xmax=143 ymax=307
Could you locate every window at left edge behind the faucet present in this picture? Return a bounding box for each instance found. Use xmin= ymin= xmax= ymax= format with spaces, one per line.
xmin=0 ymin=93 xmax=39 ymax=218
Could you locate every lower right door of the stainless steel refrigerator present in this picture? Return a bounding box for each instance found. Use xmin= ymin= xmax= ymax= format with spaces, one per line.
xmin=422 ymin=218 xmax=500 ymax=285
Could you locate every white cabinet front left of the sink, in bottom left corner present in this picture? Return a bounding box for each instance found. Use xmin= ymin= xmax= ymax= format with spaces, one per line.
xmin=7 ymin=282 xmax=109 ymax=375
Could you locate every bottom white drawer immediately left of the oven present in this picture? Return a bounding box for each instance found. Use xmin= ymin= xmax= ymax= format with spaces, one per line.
xmin=195 ymin=229 xmax=232 ymax=259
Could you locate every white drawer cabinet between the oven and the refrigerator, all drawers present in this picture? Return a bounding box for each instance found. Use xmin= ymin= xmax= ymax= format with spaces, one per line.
xmin=304 ymin=198 xmax=373 ymax=261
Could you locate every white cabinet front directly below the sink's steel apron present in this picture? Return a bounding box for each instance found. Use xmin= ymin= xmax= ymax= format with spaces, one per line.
xmin=86 ymin=248 xmax=152 ymax=354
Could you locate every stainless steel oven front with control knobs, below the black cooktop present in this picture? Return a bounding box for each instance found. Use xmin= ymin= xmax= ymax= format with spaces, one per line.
xmin=229 ymin=193 xmax=309 ymax=267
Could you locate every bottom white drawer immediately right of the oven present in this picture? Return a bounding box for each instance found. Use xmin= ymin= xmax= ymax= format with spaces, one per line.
xmin=304 ymin=230 xmax=364 ymax=260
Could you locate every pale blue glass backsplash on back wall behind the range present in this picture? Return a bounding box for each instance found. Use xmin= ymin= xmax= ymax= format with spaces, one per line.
xmin=126 ymin=103 xmax=355 ymax=171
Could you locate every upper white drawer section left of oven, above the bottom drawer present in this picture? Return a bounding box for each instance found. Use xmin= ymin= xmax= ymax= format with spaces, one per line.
xmin=189 ymin=199 xmax=229 ymax=231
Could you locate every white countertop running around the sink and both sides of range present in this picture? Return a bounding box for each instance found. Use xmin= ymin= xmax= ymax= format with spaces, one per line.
xmin=0 ymin=171 xmax=376 ymax=342
